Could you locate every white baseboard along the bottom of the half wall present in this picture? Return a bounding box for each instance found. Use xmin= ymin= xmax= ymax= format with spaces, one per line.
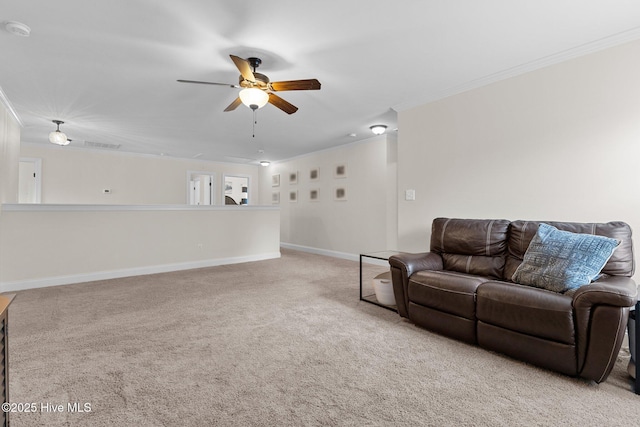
xmin=0 ymin=251 xmax=281 ymax=292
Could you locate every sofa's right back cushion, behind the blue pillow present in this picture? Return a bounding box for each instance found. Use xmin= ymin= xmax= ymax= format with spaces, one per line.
xmin=503 ymin=220 xmax=635 ymax=281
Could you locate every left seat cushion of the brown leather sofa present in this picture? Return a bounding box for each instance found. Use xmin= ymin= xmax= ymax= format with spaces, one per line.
xmin=408 ymin=270 xmax=489 ymax=319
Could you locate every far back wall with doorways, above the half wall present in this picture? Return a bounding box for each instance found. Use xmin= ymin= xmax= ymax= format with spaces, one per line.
xmin=20 ymin=143 xmax=260 ymax=205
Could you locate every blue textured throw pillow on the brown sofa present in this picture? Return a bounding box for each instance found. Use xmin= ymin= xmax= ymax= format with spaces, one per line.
xmin=511 ymin=223 xmax=620 ymax=292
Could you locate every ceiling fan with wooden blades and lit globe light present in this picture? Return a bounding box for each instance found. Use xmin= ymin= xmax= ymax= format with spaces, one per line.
xmin=178 ymin=55 xmax=320 ymax=114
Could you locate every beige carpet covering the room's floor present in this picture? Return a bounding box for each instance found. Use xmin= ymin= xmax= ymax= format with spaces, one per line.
xmin=9 ymin=250 xmax=640 ymax=427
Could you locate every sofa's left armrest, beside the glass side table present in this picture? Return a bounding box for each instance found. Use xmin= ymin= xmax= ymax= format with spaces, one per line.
xmin=389 ymin=252 xmax=443 ymax=317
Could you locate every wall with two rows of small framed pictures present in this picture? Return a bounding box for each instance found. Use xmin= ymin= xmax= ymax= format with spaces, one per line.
xmin=260 ymin=135 xmax=397 ymax=256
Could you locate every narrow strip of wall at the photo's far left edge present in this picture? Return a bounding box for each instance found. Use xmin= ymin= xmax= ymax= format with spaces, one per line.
xmin=0 ymin=104 xmax=20 ymax=204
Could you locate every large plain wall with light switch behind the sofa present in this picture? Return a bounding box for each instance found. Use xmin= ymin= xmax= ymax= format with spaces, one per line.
xmin=398 ymin=41 xmax=640 ymax=252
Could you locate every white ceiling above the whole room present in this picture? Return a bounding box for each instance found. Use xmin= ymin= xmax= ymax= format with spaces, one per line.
xmin=0 ymin=0 xmax=640 ymax=162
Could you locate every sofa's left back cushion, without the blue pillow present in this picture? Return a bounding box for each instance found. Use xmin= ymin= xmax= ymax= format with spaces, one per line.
xmin=431 ymin=218 xmax=510 ymax=278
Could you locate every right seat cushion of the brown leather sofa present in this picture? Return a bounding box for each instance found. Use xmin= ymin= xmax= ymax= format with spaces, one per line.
xmin=476 ymin=281 xmax=575 ymax=345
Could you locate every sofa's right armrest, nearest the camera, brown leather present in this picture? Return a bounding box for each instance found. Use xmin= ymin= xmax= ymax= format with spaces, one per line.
xmin=573 ymin=276 xmax=638 ymax=383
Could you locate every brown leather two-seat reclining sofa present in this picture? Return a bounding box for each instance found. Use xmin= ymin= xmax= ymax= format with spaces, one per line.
xmin=389 ymin=218 xmax=637 ymax=383
